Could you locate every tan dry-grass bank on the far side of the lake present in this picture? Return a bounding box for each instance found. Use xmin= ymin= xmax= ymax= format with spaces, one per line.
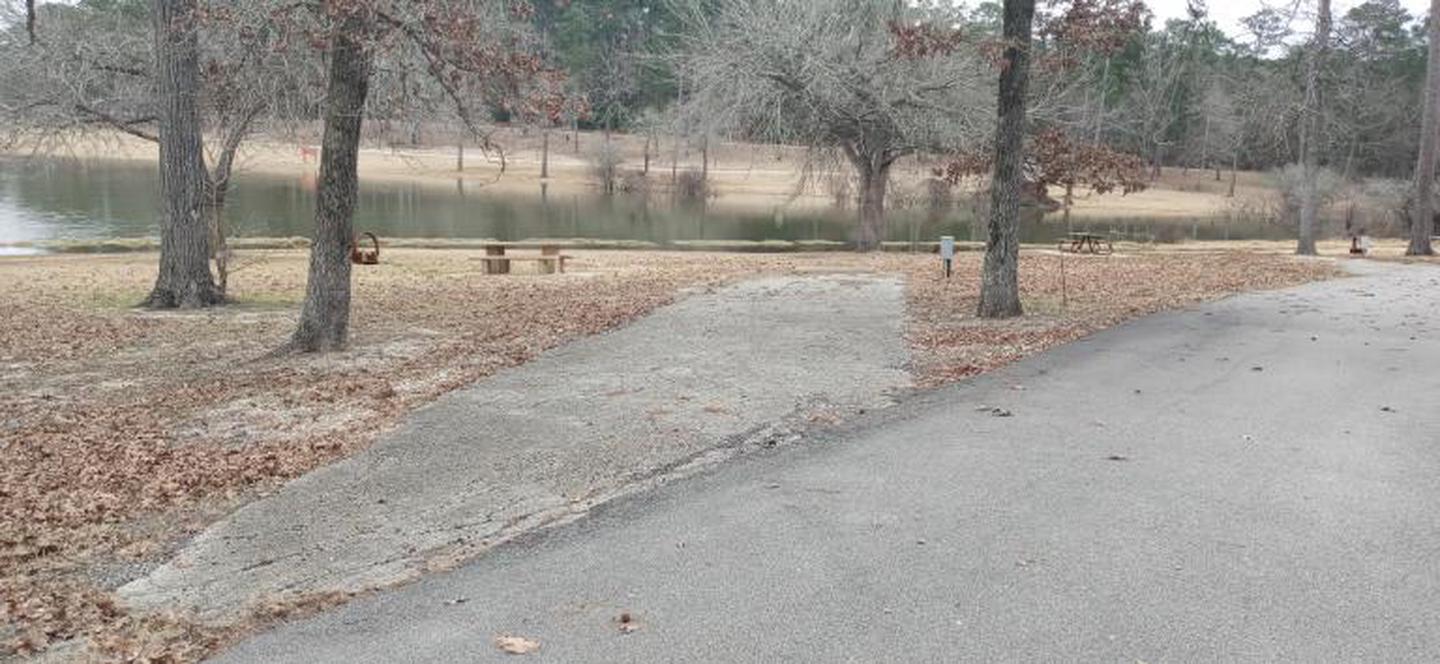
xmin=0 ymin=130 xmax=1273 ymax=220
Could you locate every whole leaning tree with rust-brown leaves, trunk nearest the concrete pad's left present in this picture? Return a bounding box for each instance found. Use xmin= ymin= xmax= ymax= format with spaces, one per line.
xmin=281 ymin=0 xmax=567 ymax=353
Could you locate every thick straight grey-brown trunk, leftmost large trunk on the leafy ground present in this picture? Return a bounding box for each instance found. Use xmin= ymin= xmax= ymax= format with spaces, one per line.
xmin=143 ymin=0 xmax=223 ymax=308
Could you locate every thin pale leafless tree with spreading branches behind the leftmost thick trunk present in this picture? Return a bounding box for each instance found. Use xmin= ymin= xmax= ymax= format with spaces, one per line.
xmin=0 ymin=0 xmax=306 ymax=297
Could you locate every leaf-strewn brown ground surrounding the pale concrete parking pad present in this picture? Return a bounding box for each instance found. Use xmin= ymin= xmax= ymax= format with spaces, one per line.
xmin=0 ymin=246 xmax=1338 ymax=661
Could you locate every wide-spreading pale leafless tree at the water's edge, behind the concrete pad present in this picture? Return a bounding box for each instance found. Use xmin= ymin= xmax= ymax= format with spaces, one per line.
xmin=677 ymin=0 xmax=991 ymax=251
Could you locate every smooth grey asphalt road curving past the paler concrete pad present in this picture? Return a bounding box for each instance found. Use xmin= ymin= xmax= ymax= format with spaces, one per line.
xmin=213 ymin=260 xmax=1440 ymax=664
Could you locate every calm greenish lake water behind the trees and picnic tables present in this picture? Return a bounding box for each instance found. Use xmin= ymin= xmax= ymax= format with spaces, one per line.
xmin=0 ymin=160 xmax=1289 ymax=254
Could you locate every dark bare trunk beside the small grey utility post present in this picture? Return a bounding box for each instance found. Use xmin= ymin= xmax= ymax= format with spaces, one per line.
xmin=978 ymin=0 xmax=1035 ymax=318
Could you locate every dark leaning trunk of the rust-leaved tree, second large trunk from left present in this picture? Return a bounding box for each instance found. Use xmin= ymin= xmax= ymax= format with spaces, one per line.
xmin=291 ymin=20 xmax=370 ymax=351
